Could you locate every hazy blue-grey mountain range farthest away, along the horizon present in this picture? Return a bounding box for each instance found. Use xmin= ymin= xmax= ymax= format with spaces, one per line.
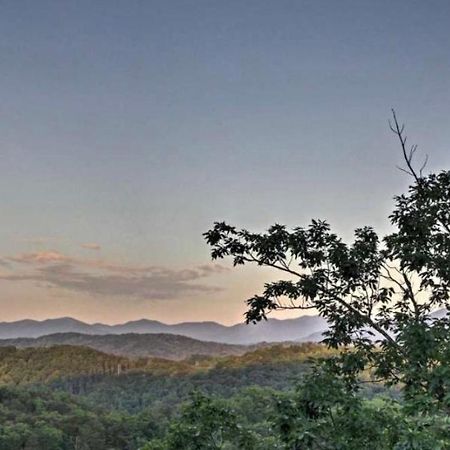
xmin=0 ymin=316 xmax=327 ymax=345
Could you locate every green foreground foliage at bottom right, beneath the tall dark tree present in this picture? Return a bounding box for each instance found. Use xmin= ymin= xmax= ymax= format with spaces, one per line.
xmin=144 ymin=373 xmax=450 ymax=450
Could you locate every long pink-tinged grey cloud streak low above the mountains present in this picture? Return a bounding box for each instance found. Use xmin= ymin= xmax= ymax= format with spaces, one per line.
xmin=0 ymin=251 xmax=228 ymax=299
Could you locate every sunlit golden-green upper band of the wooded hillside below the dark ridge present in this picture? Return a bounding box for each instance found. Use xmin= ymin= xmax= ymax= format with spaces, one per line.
xmin=0 ymin=344 xmax=331 ymax=385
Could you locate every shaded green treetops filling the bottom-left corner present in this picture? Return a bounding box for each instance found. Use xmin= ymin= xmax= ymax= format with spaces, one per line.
xmin=0 ymin=386 xmax=163 ymax=450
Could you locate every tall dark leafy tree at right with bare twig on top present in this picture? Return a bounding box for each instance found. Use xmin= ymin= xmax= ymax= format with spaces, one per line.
xmin=204 ymin=112 xmax=450 ymax=412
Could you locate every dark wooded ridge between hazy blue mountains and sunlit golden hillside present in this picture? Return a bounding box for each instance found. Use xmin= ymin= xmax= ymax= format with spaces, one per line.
xmin=0 ymin=333 xmax=250 ymax=360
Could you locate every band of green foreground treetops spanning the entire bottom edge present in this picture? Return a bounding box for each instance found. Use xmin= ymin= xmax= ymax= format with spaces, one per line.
xmin=0 ymin=371 xmax=450 ymax=450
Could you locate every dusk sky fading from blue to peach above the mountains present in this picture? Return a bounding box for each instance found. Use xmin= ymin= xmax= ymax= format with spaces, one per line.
xmin=0 ymin=0 xmax=450 ymax=324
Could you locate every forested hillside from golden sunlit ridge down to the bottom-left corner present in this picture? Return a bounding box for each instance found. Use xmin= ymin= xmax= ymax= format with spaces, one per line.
xmin=0 ymin=344 xmax=338 ymax=450
